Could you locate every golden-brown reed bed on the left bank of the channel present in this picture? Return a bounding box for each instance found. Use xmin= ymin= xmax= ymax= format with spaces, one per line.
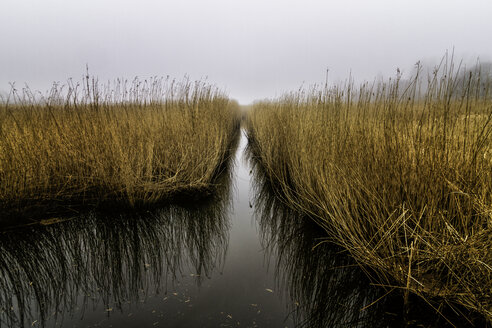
xmin=0 ymin=76 xmax=239 ymax=218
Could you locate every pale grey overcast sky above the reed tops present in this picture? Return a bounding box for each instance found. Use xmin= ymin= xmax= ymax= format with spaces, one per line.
xmin=0 ymin=0 xmax=492 ymax=104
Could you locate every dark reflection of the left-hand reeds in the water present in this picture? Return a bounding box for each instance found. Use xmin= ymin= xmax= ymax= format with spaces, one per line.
xmin=0 ymin=169 xmax=231 ymax=327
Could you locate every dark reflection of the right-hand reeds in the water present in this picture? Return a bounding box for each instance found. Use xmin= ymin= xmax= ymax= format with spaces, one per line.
xmin=247 ymin=155 xmax=485 ymax=328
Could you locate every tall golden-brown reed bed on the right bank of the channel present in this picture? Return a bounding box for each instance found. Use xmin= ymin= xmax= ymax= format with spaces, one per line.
xmin=248 ymin=61 xmax=492 ymax=320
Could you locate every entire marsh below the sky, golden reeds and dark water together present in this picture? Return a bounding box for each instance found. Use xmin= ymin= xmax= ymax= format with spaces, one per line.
xmin=0 ymin=57 xmax=492 ymax=328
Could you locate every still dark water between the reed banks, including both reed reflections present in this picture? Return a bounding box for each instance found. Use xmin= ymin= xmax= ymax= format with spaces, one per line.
xmin=0 ymin=135 xmax=484 ymax=327
